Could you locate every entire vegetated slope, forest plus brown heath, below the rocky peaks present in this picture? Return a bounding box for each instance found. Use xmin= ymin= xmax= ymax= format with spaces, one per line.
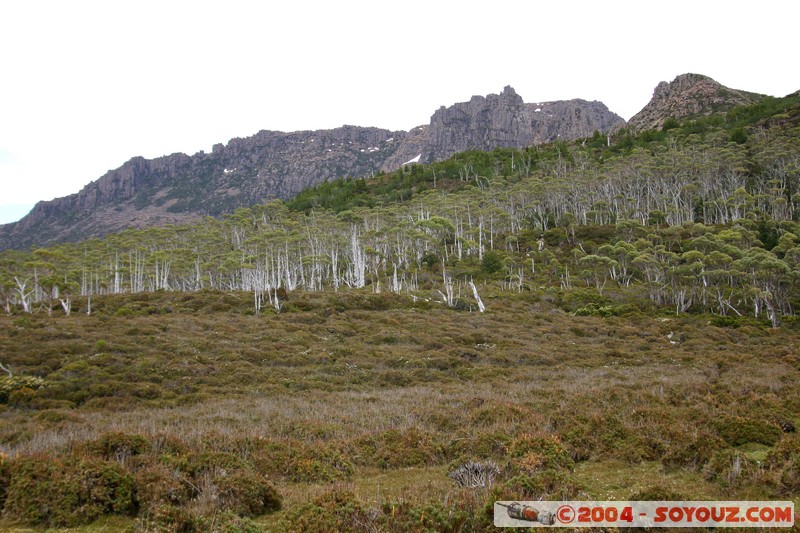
xmin=0 ymin=94 xmax=800 ymax=533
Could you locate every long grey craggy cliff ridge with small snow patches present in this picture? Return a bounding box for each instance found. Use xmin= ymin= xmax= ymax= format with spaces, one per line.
xmin=0 ymin=87 xmax=624 ymax=249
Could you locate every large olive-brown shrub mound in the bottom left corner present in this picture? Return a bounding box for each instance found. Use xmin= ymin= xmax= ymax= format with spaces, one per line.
xmin=4 ymin=455 xmax=137 ymax=527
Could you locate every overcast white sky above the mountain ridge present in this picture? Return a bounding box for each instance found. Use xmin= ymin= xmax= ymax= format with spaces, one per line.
xmin=0 ymin=0 xmax=800 ymax=223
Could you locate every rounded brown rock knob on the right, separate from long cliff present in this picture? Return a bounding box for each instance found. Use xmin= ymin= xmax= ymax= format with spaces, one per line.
xmin=627 ymin=74 xmax=764 ymax=132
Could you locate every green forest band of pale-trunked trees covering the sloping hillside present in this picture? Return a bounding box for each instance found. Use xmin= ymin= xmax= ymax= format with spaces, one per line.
xmin=0 ymin=90 xmax=800 ymax=326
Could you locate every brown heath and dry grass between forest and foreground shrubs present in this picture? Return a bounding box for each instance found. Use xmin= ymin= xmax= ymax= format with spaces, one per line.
xmin=0 ymin=291 xmax=800 ymax=525
